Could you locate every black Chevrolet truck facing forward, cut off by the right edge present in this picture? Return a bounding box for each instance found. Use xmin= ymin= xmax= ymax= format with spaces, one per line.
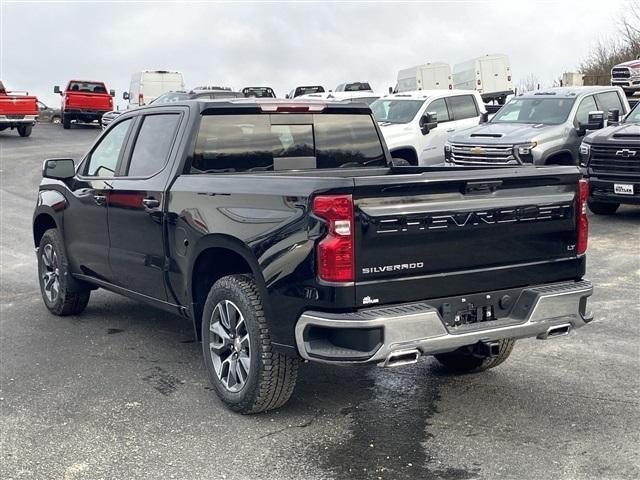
xmin=580 ymin=103 xmax=640 ymax=215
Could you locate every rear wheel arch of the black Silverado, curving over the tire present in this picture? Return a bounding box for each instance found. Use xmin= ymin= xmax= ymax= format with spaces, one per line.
xmin=187 ymin=234 xmax=270 ymax=339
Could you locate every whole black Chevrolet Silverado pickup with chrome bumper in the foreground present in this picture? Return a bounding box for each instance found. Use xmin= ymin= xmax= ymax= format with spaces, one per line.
xmin=33 ymin=99 xmax=592 ymax=413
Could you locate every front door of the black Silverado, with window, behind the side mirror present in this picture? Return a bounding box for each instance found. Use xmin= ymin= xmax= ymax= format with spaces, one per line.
xmin=64 ymin=119 xmax=131 ymax=282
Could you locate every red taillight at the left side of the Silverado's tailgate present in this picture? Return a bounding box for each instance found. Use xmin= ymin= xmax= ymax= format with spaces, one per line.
xmin=313 ymin=195 xmax=355 ymax=282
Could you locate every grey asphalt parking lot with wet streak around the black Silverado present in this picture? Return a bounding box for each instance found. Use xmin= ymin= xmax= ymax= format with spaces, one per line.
xmin=0 ymin=125 xmax=640 ymax=480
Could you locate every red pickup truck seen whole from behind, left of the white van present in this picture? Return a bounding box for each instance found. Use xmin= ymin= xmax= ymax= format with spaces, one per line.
xmin=53 ymin=80 xmax=116 ymax=129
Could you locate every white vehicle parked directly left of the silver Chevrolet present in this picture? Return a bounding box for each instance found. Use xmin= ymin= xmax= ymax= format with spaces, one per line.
xmin=371 ymin=90 xmax=486 ymax=165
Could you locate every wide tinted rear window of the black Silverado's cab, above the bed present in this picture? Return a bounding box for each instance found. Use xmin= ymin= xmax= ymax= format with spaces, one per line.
xmin=191 ymin=114 xmax=386 ymax=173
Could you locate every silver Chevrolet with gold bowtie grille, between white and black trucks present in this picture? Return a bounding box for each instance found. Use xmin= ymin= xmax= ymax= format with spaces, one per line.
xmin=444 ymin=87 xmax=630 ymax=166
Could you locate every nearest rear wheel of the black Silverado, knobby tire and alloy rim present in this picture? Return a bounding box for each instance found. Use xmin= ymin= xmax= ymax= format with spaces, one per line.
xmin=202 ymin=275 xmax=298 ymax=414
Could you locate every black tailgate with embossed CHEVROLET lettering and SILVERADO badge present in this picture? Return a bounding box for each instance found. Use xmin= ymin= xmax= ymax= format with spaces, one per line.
xmin=353 ymin=167 xmax=584 ymax=304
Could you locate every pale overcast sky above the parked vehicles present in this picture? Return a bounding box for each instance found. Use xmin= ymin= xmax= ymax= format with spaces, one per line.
xmin=0 ymin=0 xmax=624 ymax=106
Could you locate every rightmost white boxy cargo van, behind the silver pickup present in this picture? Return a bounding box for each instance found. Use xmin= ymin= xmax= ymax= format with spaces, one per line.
xmin=453 ymin=54 xmax=513 ymax=104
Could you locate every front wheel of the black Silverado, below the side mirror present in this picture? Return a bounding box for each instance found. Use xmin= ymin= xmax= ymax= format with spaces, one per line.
xmin=38 ymin=228 xmax=91 ymax=316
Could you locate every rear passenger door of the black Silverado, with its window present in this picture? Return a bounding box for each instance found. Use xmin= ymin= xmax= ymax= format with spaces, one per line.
xmin=109 ymin=111 xmax=183 ymax=300
